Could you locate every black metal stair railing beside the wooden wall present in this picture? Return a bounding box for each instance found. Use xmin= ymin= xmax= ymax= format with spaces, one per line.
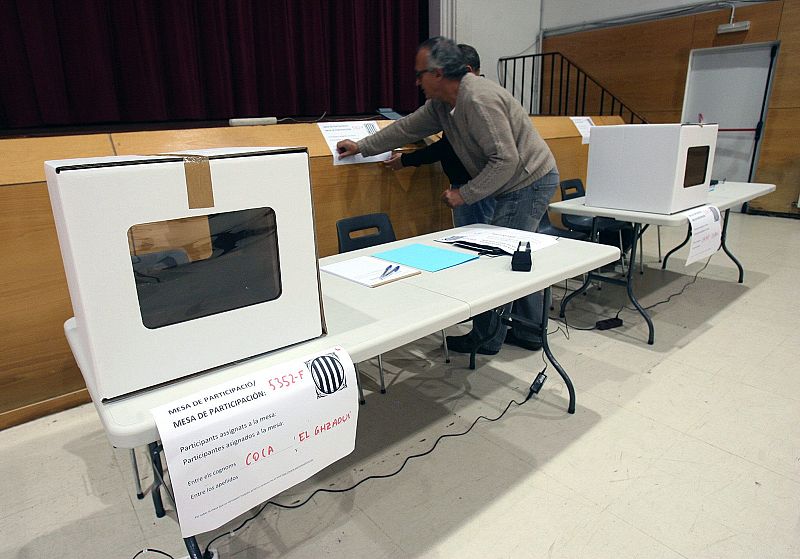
xmin=497 ymin=52 xmax=647 ymax=124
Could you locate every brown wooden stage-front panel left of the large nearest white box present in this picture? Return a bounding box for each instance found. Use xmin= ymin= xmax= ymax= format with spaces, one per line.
xmin=0 ymin=182 xmax=88 ymax=428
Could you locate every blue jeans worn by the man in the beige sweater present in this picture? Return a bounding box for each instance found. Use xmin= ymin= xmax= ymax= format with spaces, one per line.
xmin=470 ymin=168 xmax=559 ymax=351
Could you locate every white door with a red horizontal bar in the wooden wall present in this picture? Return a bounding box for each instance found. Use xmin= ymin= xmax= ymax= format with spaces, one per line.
xmin=681 ymin=43 xmax=778 ymax=182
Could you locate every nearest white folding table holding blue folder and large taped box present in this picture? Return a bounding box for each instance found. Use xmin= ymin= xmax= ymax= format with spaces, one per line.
xmin=64 ymin=226 xmax=619 ymax=559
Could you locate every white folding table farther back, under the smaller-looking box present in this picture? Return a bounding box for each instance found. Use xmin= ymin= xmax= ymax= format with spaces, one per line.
xmin=550 ymin=182 xmax=775 ymax=345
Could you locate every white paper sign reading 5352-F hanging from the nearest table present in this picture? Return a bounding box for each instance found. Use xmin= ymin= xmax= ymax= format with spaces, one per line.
xmin=152 ymin=347 xmax=358 ymax=538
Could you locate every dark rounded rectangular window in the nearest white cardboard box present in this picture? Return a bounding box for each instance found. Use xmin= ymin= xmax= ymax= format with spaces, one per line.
xmin=128 ymin=208 xmax=281 ymax=329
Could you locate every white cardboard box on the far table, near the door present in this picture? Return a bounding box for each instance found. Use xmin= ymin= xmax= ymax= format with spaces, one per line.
xmin=586 ymin=124 xmax=718 ymax=214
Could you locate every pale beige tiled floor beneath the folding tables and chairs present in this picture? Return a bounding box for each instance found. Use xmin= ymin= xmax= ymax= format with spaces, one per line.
xmin=0 ymin=215 xmax=800 ymax=559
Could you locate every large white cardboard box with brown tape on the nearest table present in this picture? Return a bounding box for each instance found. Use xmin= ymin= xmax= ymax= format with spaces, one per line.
xmin=45 ymin=148 xmax=325 ymax=400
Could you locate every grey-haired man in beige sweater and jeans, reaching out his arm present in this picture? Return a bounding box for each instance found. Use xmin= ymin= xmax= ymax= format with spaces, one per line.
xmin=337 ymin=37 xmax=559 ymax=355
